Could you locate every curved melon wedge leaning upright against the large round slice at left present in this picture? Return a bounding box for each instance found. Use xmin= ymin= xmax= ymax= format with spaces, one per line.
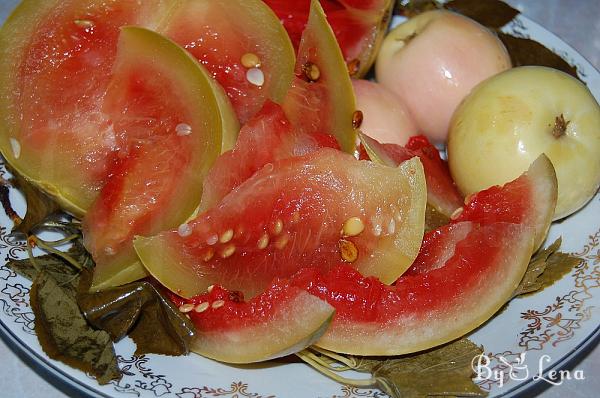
xmin=83 ymin=27 xmax=232 ymax=290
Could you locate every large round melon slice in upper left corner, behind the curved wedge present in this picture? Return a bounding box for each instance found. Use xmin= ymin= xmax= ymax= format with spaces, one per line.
xmin=0 ymin=0 xmax=295 ymax=216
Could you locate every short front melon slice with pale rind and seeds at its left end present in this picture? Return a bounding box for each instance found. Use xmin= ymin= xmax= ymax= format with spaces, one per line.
xmin=173 ymin=282 xmax=335 ymax=364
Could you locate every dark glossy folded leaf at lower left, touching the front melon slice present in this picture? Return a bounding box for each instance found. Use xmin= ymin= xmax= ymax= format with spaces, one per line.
xmin=78 ymin=273 xmax=195 ymax=355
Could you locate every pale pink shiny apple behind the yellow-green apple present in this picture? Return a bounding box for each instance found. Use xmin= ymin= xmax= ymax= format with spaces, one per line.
xmin=375 ymin=10 xmax=511 ymax=144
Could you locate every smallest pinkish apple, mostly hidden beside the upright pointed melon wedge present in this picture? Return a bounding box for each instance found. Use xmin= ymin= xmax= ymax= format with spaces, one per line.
xmin=352 ymin=80 xmax=418 ymax=145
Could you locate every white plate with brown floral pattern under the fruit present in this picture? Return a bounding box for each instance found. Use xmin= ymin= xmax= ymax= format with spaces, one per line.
xmin=0 ymin=5 xmax=600 ymax=398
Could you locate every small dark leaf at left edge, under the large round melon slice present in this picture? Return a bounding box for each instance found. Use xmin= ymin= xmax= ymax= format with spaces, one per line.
xmin=5 ymin=173 xmax=60 ymax=234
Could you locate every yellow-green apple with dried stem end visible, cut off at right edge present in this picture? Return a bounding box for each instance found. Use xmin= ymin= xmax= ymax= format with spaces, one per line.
xmin=447 ymin=66 xmax=600 ymax=220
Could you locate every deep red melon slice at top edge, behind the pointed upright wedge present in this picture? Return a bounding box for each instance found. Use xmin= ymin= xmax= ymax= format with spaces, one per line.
xmin=264 ymin=0 xmax=394 ymax=78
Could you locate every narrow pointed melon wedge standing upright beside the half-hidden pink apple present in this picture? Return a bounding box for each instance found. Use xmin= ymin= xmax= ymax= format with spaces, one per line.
xmin=283 ymin=0 xmax=356 ymax=154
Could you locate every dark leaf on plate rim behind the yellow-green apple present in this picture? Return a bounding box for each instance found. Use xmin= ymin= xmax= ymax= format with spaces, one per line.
xmin=498 ymin=32 xmax=581 ymax=80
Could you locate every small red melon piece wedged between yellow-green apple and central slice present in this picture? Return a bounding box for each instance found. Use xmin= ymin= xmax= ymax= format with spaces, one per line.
xmin=360 ymin=133 xmax=463 ymax=217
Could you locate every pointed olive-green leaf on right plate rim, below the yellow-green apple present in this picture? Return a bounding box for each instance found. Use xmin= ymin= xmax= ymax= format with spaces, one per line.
xmin=513 ymin=238 xmax=581 ymax=297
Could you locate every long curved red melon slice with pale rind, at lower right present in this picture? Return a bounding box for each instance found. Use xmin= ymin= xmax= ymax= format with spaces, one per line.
xmin=293 ymin=222 xmax=533 ymax=355
